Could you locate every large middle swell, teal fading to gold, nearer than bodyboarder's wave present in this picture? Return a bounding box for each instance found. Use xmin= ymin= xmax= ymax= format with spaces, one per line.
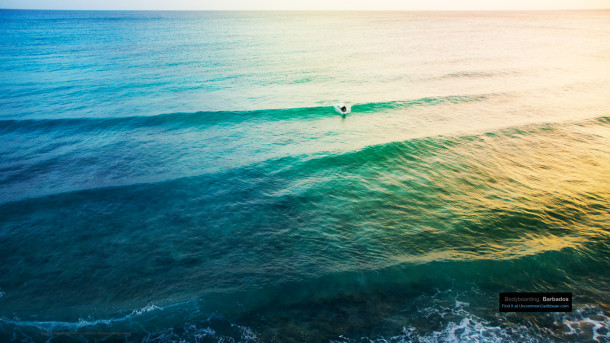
xmin=0 ymin=117 xmax=608 ymax=261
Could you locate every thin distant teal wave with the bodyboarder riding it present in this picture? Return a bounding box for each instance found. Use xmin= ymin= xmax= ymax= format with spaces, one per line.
xmin=0 ymin=95 xmax=490 ymax=134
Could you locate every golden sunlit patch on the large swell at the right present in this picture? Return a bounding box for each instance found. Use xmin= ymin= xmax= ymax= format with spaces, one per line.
xmin=332 ymin=118 xmax=610 ymax=268
